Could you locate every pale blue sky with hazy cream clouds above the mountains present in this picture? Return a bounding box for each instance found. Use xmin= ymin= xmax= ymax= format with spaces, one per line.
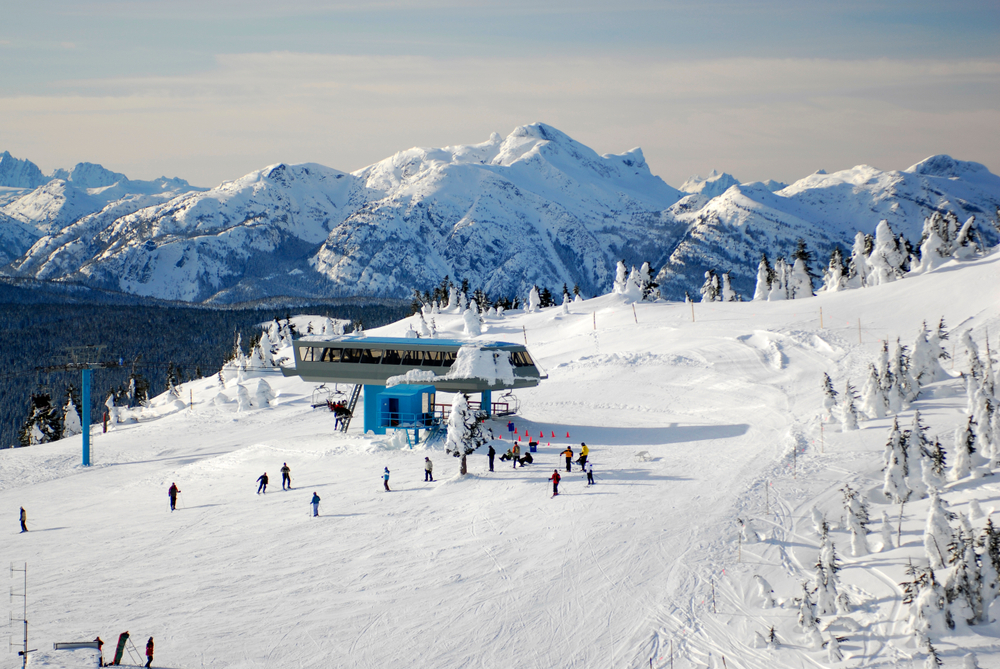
xmin=0 ymin=0 xmax=1000 ymax=186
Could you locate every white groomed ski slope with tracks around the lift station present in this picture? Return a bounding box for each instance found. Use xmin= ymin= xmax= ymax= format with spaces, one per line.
xmin=0 ymin=253 xmax=1000 ymax=669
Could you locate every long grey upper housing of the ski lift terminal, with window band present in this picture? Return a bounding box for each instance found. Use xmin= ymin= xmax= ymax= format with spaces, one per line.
xmin=282 ymin=335 xmax=548 ymax=393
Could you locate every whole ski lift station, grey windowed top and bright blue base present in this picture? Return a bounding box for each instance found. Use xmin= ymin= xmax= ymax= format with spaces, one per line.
xmin=281 ymin=335 xmax=548 ymax=434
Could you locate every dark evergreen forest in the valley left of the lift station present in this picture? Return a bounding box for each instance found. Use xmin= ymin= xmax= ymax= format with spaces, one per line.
xmin=0 ymin=303 xmax=408 ymax=448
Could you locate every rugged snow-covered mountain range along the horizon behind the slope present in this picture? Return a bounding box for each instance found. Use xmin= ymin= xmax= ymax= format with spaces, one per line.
xmin=0 ymin=123 xmax=1000 ymax=302
